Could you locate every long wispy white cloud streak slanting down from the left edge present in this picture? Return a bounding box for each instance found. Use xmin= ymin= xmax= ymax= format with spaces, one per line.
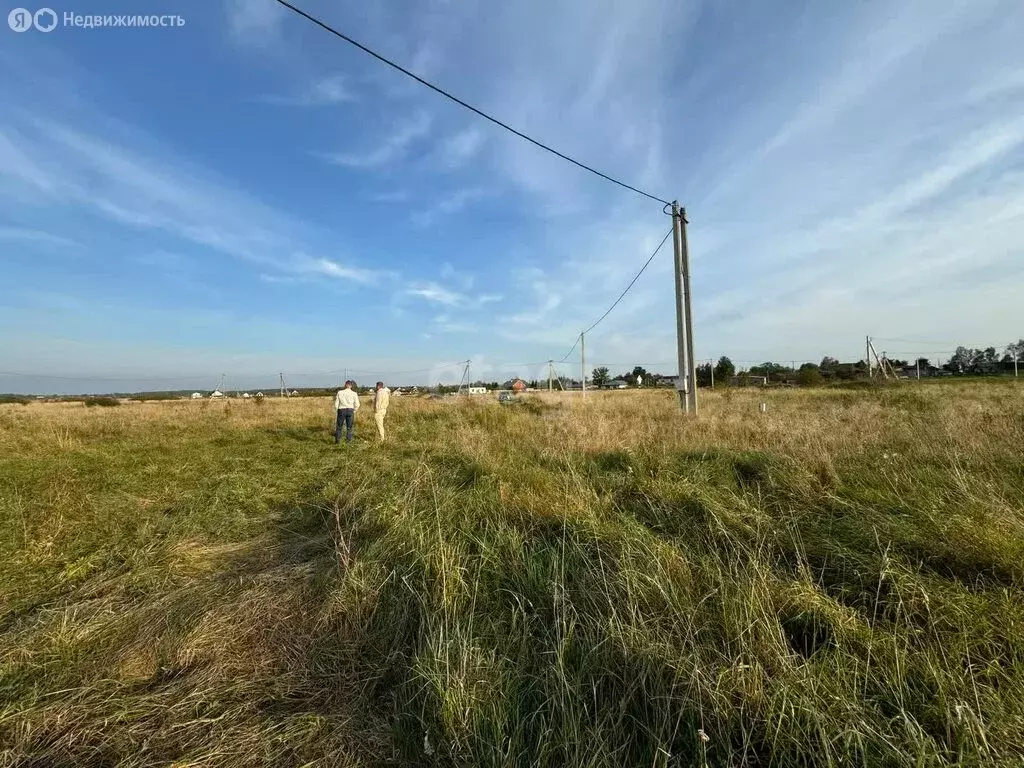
xmin=0 ymin=112 xmax=377 ymax=284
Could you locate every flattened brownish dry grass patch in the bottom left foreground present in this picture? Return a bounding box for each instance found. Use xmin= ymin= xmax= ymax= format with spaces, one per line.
xmin=0 ymin=486 xmax=403 ymax=766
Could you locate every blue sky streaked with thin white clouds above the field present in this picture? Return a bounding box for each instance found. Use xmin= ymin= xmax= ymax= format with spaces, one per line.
xmin=0 ymin=0 xmax=1024 ymax=392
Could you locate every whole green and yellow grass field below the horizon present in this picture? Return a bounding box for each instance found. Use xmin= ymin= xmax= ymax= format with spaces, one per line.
xmin=0 ymin=382 xmax=1024 ymax=768
